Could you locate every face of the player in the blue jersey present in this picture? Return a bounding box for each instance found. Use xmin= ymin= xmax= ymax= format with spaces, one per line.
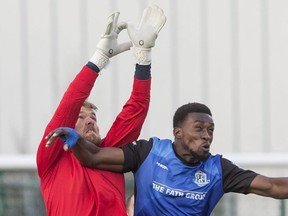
xmin=174 ymin=112 xmax=214 ymax=163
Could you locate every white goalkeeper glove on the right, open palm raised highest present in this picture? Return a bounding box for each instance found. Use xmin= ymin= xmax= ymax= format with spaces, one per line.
xmin=127 ymin=5 xmax=166 ymax=65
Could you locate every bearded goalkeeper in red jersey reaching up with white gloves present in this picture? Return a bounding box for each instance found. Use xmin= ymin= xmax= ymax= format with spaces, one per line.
xmin=37 ymin=6 xmax=166 ymax=216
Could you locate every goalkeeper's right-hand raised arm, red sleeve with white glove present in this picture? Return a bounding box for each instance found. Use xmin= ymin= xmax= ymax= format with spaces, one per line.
xmin=101 ymin=5 xmax=166 ymax=147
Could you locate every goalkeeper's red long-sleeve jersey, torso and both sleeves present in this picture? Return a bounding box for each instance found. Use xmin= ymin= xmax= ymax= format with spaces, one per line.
xmin=37 ymin=66 xmax=151 ymax=216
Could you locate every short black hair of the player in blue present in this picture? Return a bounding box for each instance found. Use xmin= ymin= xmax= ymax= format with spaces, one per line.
xmin=173 ymin=102 xmax=212 ymax=128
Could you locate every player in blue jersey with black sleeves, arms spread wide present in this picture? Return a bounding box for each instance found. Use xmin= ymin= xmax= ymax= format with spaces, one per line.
xmin=44 ymin=103 xmax=288 ymax=216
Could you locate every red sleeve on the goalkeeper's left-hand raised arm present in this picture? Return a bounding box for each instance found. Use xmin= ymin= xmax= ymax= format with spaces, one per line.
xmin=36 ymin=66 xmax=98 ymax=177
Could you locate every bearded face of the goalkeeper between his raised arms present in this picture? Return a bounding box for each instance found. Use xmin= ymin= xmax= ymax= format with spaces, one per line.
xmin=75 ymin=106 xmax=101 ymax=145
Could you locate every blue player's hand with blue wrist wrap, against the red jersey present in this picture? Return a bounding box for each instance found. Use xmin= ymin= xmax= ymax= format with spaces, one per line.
xmin=45 ymin=127 xmax=79 ymax=151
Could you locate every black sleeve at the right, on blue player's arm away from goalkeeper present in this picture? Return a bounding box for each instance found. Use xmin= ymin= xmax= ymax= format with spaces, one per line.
xmin=221 ymin=158 xmax=258 ymax=194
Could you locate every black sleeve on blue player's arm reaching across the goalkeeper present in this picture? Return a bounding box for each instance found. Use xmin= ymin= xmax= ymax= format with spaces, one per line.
xmin=122 ymin=139 xmax=153 ymax=173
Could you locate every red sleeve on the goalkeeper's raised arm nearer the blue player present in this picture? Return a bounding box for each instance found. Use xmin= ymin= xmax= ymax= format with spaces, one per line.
xmin=101 ymin=66 xmax=151 ymax=147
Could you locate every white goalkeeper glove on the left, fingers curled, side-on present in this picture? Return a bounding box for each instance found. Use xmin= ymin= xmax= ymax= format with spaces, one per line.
xmin=89 ymin=12 xmax=132 ymax=70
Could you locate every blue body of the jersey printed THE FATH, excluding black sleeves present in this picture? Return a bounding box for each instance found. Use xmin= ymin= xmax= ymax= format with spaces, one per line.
xmin=135 ymin=138 xmax=224 ymax=216
